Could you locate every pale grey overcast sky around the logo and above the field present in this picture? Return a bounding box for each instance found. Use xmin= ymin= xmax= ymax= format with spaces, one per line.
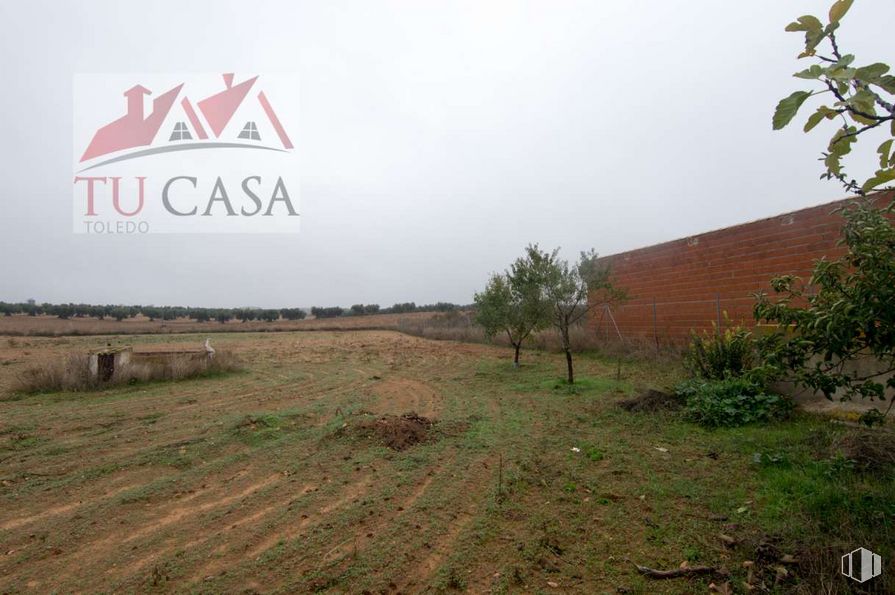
xmin=0 ymin=0 xmax=895 ymax=307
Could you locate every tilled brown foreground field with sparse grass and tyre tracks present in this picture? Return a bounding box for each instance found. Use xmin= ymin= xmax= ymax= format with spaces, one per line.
xmin=0 ymin=331 xmax=892 ymax=593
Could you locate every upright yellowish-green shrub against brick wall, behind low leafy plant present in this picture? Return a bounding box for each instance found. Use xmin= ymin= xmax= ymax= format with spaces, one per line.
xmin=684 ymin=326 xmax=756 ymax=380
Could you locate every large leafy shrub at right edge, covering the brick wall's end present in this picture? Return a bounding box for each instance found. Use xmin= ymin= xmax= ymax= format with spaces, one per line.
xmin=754 ymin=200 xmax=895 ymax=411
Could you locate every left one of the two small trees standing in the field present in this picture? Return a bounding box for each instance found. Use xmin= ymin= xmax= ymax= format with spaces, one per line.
xmin=475 ymin=248 xmax=549 ymax=368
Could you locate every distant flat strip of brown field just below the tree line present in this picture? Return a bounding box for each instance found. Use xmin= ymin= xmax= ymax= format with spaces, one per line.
xmin=0 ymin=312 xmax=435 ymax=336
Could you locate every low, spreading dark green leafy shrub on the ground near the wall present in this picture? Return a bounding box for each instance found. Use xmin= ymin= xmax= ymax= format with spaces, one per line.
xmin=676 ymin=377 xmax=793 ymax=427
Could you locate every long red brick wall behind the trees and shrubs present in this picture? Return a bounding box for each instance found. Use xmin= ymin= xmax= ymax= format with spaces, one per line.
xmin=590 ymin=196 xmax=891 ymax=344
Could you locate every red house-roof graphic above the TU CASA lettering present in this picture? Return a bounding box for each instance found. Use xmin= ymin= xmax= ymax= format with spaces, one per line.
xmin=80 ymin=73 xmax=293 ymax=162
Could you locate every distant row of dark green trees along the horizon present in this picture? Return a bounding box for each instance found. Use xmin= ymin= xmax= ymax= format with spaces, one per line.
xmin=0 ymin=300 xmax=472 ymax=323
